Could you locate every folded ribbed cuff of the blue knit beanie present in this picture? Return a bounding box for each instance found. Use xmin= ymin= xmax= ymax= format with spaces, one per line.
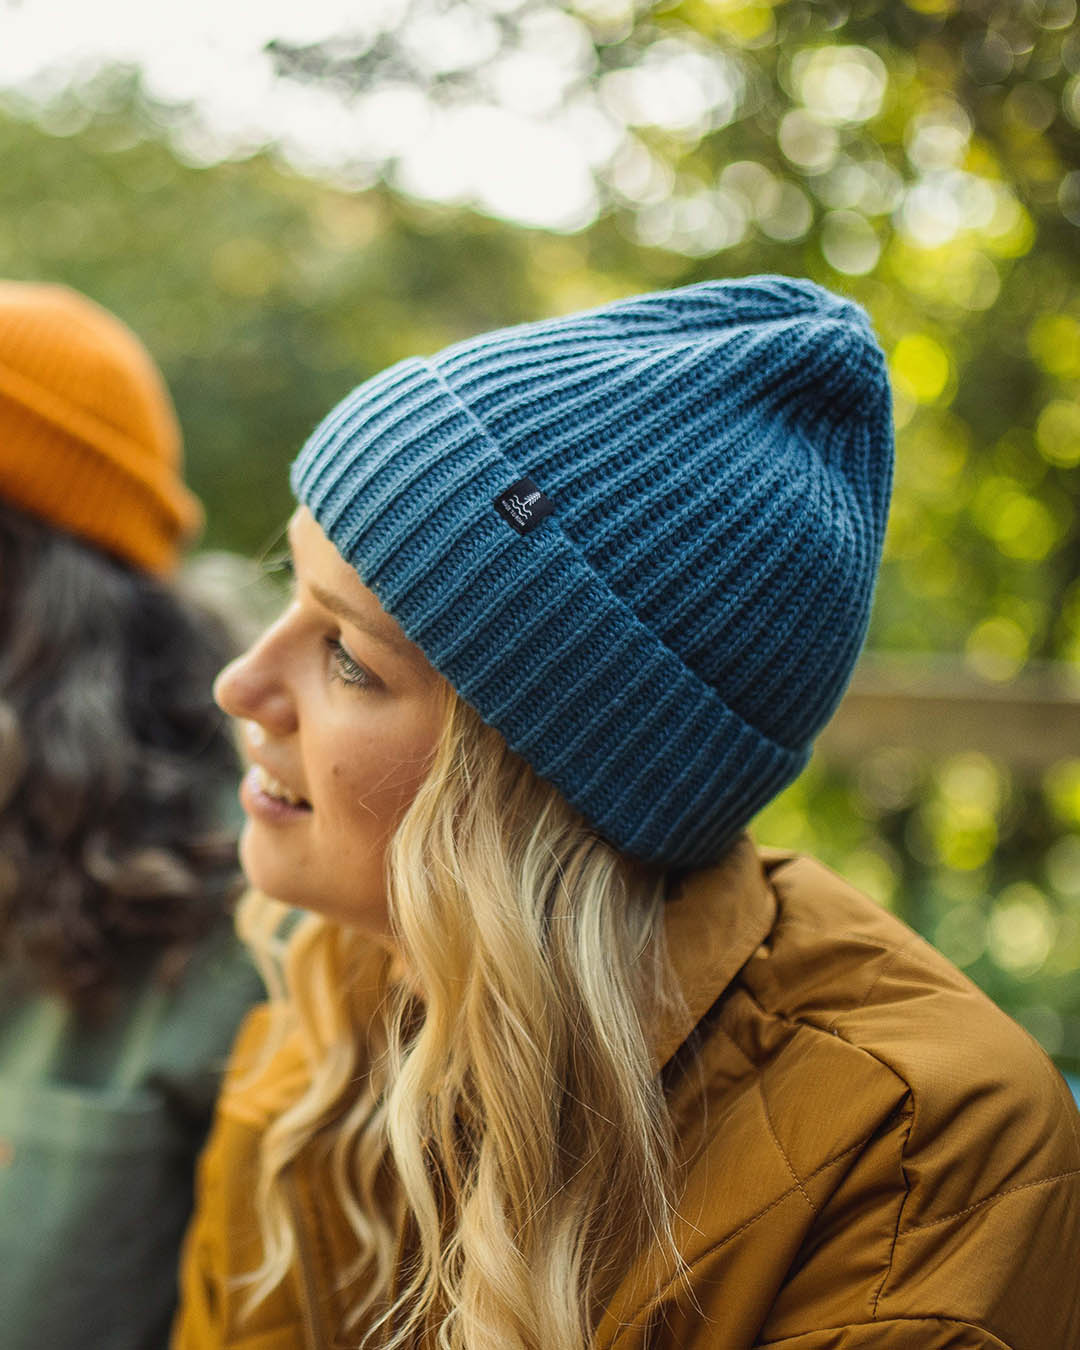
xmin=292 ymin=359 xmax=809 ymax=867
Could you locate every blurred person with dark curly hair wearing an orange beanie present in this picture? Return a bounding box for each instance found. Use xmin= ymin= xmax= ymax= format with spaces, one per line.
xmin=0 ymin=282 xmax=261 ymax=1350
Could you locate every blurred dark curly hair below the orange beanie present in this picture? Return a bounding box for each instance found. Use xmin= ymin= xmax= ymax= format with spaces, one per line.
xmin=0 ymin=502 xmax=238 ymax=1007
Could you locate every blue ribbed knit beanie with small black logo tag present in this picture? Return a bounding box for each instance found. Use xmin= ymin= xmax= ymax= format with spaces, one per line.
xmin=292 ymin=277 xmax=892 ymax=867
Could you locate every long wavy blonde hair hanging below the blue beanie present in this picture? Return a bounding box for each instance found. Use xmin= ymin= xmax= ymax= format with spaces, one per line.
xmin=240 ymin=691 xmax=679 ymax=1350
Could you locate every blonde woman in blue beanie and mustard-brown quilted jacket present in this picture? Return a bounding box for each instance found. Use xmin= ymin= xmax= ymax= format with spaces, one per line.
xmin=174 ymin=277 xmax=1080 ymax=1350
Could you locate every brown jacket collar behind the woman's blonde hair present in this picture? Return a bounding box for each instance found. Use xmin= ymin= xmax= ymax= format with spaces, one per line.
xmin=652 ymin=834 xmax=776 ymax=1071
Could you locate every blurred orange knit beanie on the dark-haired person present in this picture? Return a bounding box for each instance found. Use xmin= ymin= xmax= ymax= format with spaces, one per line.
xmin=0 ymin=281 xmax=203 ymax=574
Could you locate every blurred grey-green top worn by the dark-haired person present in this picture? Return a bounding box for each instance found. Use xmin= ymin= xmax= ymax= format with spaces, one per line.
xmin=0 ymin=925 xmax=262 ymax=1350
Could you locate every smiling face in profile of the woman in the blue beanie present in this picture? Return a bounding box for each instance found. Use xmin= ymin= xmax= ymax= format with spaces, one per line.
xmin=215 ymin=506 xmax=446 ymax=936
